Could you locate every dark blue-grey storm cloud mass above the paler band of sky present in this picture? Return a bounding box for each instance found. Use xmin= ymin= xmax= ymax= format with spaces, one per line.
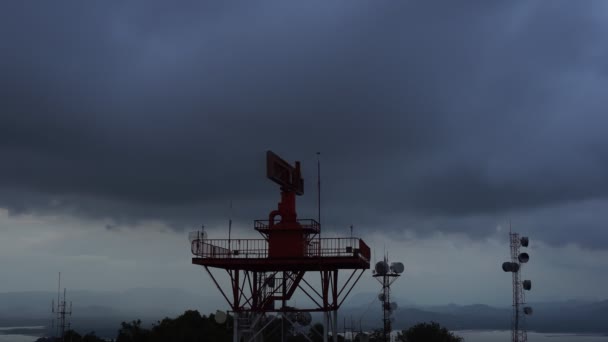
xmin=0 ymin=1 xmax=608 ymax=247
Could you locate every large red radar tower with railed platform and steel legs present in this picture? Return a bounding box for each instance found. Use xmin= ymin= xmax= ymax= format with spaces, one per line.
xmin=191 ymin=151 xmax=371 ymax=342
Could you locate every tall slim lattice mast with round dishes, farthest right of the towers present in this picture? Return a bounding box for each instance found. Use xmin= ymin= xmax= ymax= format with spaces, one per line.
xmin=502 ymin=229 xmax=532 ymax=342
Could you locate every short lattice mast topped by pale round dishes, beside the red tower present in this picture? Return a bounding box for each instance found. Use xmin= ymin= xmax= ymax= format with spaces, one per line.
xmin=373 ymin=255 xmax=405 ymax=342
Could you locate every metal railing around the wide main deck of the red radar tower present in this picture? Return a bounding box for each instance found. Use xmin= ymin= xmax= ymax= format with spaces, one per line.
xmin=191 ymin=238 xmax=370 ymax=261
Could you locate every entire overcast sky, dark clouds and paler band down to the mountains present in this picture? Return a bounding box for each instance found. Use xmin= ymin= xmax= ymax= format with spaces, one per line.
xmin=0 ymin=0 xmax=608 ymax=305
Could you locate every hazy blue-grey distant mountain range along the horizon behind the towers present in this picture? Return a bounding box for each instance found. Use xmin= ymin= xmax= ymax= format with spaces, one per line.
xmin=0 ymin=288 xmax=608 ymax=337
